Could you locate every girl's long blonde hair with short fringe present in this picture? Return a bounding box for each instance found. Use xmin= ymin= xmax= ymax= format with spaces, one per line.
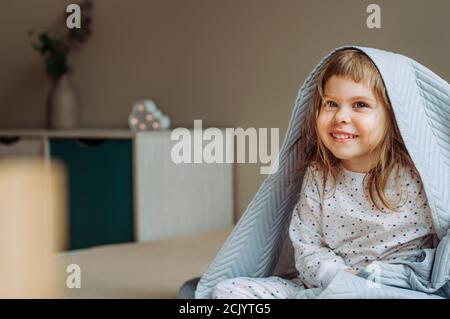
xmin=293 ymin=49 xmax=418 ymax=211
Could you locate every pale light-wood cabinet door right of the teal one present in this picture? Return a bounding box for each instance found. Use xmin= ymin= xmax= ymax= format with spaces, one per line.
xmin=135 ymin=131 xmax=233 ymax=241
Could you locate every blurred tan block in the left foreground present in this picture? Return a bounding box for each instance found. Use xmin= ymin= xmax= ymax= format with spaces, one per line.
xmin=0 ymin=159 xmax=65 ymax=298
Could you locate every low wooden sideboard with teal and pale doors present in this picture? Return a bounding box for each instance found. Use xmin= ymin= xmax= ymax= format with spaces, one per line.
xmin=0 ymin=129 xmax=234 ymax=250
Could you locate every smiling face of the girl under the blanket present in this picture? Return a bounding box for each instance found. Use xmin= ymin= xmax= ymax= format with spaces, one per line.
xmin=316 ymin=75 xmax=388 ymax=173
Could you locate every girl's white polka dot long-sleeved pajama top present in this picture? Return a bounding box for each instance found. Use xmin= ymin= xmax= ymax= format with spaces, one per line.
xmin=289 ymin=166 xmax=434 ymax=288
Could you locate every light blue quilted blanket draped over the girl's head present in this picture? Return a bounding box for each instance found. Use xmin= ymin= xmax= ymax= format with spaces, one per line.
xmin=195 ymin=46 xmax=450 ymax=298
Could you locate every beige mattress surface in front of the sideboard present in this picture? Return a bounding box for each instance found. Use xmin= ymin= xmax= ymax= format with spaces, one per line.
xmin=57 ymin=229 xmax=231 ymax=299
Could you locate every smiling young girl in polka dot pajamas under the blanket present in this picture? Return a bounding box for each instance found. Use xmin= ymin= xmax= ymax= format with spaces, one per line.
xmin=212 ymin=49 xmax=435 ymax=298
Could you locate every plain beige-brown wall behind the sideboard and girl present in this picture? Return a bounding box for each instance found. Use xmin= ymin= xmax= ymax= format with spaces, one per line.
xmin=0 ymin=0 xmax=450 ymax=220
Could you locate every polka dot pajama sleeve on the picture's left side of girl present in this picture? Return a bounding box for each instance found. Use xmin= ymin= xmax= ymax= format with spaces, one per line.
xmin=289 ymin=168 xmax=349 ymax=288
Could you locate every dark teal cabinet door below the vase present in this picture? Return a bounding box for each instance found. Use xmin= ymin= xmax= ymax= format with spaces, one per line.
xmin=49 ymin=138 xmax=134 ymax=250
